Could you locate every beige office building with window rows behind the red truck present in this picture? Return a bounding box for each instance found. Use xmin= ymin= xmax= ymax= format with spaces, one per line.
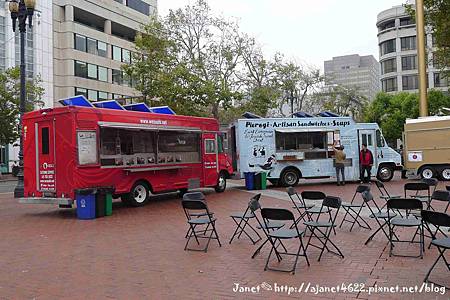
xmin=53 ymin=0 xmax=157 ymax=105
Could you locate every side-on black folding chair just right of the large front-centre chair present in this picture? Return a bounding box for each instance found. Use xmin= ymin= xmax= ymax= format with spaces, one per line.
xmin=304 ymin=196 xmax=344 ymax=261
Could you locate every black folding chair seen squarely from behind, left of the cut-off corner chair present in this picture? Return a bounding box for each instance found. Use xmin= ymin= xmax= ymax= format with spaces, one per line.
xmin=387 ymin=198 xmax=425 ymax=258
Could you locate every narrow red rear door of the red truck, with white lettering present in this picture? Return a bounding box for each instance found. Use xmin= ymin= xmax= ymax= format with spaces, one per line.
xmin=35 ymin=120 xmax=56 ymax=192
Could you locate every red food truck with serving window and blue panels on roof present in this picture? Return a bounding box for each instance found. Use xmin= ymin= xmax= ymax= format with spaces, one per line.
xmin=20 ymin=99 xmax=233 ymax=207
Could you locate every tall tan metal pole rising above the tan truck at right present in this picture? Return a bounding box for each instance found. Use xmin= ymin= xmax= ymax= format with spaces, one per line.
xmin=416 ymin=0 xmax=428 ymax=117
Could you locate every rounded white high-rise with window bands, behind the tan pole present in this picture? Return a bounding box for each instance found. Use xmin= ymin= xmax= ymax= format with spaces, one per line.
xmin=377 ymin=6 xmax=449 ymax=93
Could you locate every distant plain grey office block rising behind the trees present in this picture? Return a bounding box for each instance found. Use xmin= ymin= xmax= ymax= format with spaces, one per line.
xmin=324 ymin=54 xmax=380 ymax=100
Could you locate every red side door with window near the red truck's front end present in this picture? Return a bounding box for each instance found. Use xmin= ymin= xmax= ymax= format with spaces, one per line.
xmin=202 ymin=133 xmax=219 ymax=186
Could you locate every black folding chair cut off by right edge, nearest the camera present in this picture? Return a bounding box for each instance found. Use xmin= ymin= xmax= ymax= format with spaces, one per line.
xmin=422 ymin=210 xmax=450 ymax=289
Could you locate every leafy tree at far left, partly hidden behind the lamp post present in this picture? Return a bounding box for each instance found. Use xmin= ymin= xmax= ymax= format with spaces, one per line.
xmin=0 ymin=68 xmax=44 ymax=145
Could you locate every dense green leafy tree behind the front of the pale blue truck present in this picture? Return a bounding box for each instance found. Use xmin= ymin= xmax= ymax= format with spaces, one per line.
xmin=365 ymin=90 xmax=450 ymax=143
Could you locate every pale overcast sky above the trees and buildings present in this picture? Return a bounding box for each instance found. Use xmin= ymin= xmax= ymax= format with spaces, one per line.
xmin=158 ymin=0 xmax=406 ymax=69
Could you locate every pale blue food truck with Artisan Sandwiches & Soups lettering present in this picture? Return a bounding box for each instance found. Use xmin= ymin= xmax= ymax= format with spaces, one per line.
xmin=230 ymin=114 xmax=402 ymax=186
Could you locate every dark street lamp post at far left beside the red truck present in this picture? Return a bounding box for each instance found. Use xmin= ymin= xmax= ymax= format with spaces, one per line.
xmin=9 ymin=0 xmax=36 ymax=198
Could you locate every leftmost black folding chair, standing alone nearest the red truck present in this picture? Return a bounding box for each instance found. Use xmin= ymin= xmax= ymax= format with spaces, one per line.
xmin=181 ymin=200 xmax=222 ymax=252
